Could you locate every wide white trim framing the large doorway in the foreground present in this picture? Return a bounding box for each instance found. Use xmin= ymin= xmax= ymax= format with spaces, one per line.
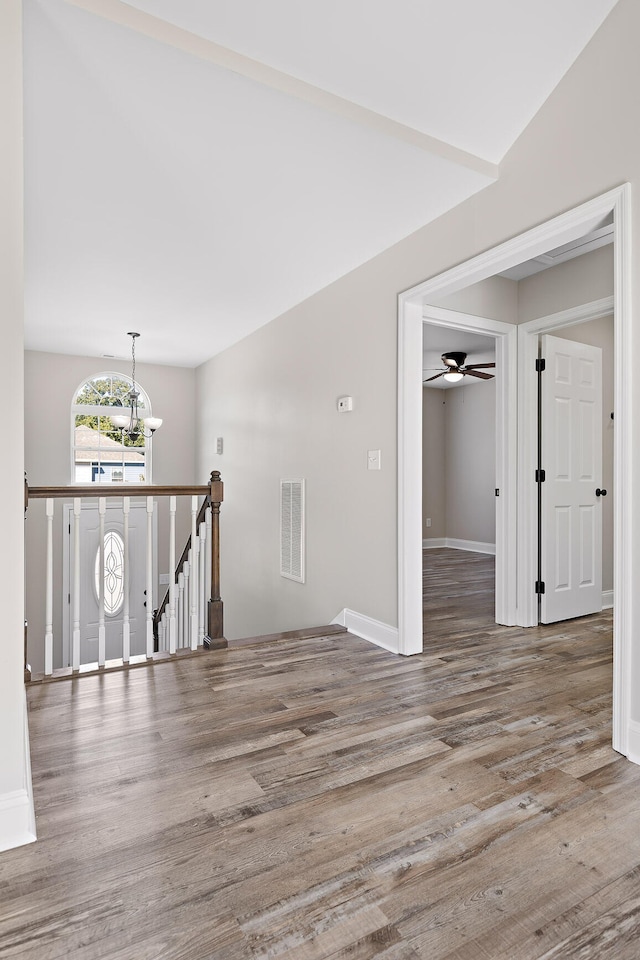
xmin=398 ymin=183 xmax=640 ymax=759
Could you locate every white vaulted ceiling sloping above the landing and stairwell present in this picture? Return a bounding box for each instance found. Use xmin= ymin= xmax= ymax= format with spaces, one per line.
xmin=24 ymin=0 xmax=616 ymax=366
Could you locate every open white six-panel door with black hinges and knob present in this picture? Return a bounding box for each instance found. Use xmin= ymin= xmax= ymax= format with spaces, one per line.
xmin=540 ymin=334 xmax=606 ymax=623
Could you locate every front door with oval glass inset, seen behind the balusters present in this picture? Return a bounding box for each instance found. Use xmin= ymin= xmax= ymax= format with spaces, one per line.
xmin=63 ymin=499 xmax=147 ymax=666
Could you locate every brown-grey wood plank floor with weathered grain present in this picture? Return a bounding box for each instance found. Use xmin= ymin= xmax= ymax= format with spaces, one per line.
xmin=0 ymin=551 xmax=640 ymax=960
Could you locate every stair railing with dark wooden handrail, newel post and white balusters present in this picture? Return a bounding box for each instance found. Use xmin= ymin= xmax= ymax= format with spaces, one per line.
xmin=25 ymin=471 xmax=226 ymax=677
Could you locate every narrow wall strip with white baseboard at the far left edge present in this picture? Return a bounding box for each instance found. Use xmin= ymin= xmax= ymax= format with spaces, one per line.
xmin=0 ymin=0 xmax=35 ymax=850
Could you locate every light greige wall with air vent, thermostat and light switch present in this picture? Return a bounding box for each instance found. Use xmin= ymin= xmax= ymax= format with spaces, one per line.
xmin=197 ymin=0 xmax=640 ymax=660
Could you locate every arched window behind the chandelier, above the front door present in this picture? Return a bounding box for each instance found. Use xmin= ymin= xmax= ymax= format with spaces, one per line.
xmin=71 ymin=373 xmax=156 ymax=483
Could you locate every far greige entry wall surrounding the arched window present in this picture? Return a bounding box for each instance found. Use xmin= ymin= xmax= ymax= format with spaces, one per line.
xmin=24 ymin=347 xmax=198 ymax=673
